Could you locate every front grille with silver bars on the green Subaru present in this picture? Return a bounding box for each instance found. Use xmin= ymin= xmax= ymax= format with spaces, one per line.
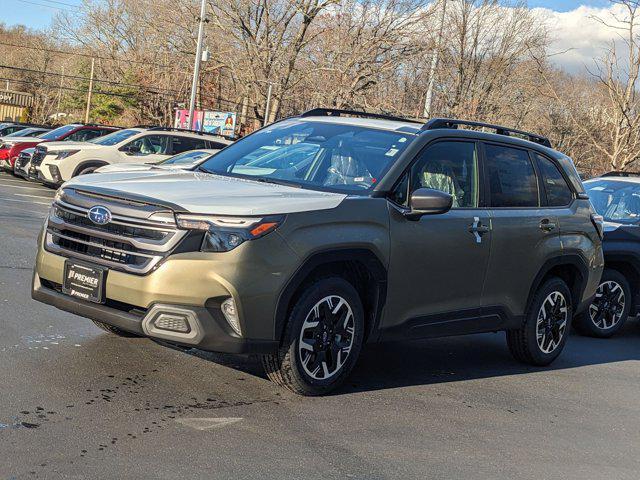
xmin=46 ymin=190 xmax=186 ymax=275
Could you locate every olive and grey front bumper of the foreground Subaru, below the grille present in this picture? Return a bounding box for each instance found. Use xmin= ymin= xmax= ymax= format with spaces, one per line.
xmin=32 ymin=227 xmax=293 ymax=354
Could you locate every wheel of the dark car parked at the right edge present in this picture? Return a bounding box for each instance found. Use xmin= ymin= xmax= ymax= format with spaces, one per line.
xmin=574 ymin=268 xmax=632 ymax=338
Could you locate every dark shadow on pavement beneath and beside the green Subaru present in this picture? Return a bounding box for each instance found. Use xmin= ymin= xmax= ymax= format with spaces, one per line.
xmin=335 ymin=320 xmax=640 ymax=395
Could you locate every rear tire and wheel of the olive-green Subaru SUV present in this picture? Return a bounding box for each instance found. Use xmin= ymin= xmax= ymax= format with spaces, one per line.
xmin=507 ymin=278 xmax=573 ymax=366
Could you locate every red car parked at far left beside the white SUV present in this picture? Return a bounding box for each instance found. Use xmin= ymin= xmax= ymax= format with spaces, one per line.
xmin=0 ymin=123 xmax=119 ymax=171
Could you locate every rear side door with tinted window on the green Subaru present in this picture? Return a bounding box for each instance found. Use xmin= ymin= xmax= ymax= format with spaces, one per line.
xmin=483 ymin=143 xmax=561 ymax=323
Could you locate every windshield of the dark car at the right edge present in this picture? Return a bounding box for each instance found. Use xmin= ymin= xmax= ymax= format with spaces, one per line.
xmin=584 ymin=179 xmax=640 ymax=224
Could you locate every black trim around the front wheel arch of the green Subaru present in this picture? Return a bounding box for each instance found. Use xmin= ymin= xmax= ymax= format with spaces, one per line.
xmin=274 ymin=247 xmax=387 ymax=342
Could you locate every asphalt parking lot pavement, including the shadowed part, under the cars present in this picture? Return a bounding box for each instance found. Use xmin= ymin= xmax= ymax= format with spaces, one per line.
xmin=0 ymin=174 xmax=640 ymax=480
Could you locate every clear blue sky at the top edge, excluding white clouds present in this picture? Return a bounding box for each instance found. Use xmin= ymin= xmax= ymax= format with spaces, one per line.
xmin=0 ymin=0 xmax=609 ymax=28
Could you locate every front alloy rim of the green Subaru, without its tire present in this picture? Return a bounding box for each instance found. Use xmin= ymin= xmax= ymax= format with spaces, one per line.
xmin=298 ymin=295 xmax=355 ymax=380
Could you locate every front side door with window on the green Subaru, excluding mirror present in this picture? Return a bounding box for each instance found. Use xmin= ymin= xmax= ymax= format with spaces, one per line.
xmin=383 ymin=140 xmax=491 ymax=337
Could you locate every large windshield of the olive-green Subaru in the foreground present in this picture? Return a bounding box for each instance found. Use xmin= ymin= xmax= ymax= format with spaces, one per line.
xmin=200 ymin=119 xmax=415 ymax=193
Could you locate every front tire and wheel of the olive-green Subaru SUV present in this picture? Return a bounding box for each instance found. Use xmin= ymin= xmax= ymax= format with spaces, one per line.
xmin=262 ymin=277 xmax=364 ymax=396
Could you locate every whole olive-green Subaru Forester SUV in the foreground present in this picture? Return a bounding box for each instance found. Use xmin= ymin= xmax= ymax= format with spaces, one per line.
xmin=33 ymin=109 xmax=603 ymax=395
